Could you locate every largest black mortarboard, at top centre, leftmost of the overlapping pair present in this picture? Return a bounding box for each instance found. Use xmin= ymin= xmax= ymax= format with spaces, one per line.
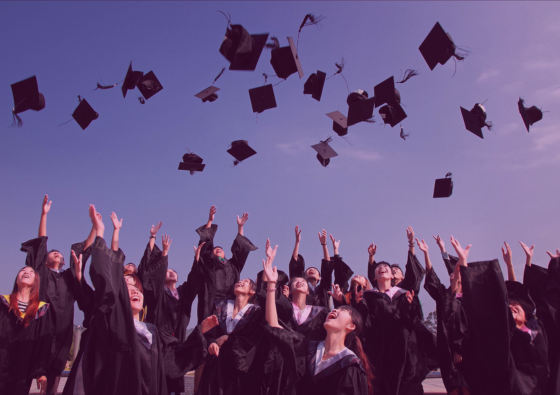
xmin=220 ymin=25 xmax=268 ymax=71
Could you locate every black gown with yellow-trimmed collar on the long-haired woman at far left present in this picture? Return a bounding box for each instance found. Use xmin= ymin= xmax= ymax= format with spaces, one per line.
xmin=0 ymin=295 xmax=52 ymax=395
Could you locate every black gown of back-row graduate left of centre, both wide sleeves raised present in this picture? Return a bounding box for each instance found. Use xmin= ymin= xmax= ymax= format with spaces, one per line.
xmin=195 ymin=224 xmax=257 ymax=324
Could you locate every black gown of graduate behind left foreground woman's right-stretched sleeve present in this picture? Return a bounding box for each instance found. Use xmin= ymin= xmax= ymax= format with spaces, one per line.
xmin=138 ymin=243 xmax=199 ymax=394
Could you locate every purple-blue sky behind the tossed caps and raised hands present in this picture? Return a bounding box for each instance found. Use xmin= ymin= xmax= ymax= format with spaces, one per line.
xmin=0 ymin=2 xmax=560 ymax=322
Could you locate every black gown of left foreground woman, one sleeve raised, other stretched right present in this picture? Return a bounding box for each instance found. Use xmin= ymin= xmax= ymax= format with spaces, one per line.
xmin=82 ymin=237 xmax=207 ymax=395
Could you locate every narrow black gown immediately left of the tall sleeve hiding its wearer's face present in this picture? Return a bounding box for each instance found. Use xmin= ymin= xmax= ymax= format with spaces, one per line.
xmin=424 ymin=268 xmax=470 ymax=393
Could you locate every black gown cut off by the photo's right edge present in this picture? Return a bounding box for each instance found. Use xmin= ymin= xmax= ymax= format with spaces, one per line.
xmin=523 ymin=258 xmax=560 ymax=395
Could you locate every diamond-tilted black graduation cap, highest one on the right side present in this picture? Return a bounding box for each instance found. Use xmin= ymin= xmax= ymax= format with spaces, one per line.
xmin=418 ymin=22 xmax=465 ymax=70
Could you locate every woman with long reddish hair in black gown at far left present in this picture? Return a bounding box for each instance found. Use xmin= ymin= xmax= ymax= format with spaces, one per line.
xmin=0 ymin=266 xmax=52 ymax=395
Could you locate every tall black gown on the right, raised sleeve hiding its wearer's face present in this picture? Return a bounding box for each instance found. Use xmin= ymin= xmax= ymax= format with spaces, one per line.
xmin=461 ymin=259 xmax=522 ymax=395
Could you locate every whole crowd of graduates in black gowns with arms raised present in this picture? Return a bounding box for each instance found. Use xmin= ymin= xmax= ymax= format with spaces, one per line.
xmin=0 ymin=196 xmax=560 ymax=395
